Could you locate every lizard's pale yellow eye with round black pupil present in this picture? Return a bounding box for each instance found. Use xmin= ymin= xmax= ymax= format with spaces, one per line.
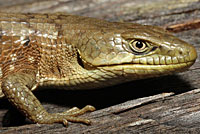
xmin=129 ymin=40 xmax=148 ymax=53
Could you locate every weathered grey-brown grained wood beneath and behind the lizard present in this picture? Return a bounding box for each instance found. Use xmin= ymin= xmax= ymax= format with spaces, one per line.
xmin=0 ymin=0 xmax=200 ymax=134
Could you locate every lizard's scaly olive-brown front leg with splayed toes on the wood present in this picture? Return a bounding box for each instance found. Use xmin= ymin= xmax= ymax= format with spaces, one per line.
xmin=2 ymin=71 xmax=95 ymax=125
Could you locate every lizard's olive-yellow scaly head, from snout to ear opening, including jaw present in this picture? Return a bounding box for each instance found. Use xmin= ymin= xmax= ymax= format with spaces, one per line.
xmin=74 ymin=24 xmax=197 ymax=87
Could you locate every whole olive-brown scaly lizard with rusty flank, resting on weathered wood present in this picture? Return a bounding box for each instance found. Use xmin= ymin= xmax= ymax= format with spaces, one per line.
xmin=0 ymin=13 xmax=197 ymax=125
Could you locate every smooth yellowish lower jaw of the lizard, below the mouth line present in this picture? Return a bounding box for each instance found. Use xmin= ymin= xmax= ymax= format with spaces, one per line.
xmin=99 ymin=62 xmax=194 ymax=80
